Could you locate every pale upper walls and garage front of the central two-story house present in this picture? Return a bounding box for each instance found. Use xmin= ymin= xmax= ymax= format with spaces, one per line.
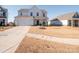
xmin=15 ymin=6 xmax=47 ymax=26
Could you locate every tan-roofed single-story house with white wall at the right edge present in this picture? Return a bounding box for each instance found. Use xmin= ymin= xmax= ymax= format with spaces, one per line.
xmin=50 ymin=12 xmax=79 ymax=26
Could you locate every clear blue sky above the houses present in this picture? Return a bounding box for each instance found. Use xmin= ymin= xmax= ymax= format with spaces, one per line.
xmin=3 ymin=5 xmax=79 ymax=22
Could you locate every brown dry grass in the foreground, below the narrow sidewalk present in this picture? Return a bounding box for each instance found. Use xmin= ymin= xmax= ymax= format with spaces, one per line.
xmin=15 ymin=37 xmax=79 ymax=53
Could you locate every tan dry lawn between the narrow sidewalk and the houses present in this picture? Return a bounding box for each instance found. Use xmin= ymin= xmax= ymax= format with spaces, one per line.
xmin=29 ymin=26 xmax=79 ymax=39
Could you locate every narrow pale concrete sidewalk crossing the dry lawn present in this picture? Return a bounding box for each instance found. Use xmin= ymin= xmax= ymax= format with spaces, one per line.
xmin=27 ymin=33 xmax=79 ymax=45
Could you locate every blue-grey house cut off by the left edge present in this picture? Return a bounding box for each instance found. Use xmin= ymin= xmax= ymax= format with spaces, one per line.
xmin=0 ymin=6 xmax=8 ymax=26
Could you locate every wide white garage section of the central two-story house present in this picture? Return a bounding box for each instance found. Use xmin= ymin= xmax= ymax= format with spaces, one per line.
xmin=15 ymin=16 xmax=33 ymax=26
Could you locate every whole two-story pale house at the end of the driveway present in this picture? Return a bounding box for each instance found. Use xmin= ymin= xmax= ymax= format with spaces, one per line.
xmin=14 ymin=6 xmax=48 ymax=26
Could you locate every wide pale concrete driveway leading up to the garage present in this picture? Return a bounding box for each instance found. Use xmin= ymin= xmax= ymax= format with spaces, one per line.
xmin=0 ymin=26 xmax=30 ymax=53
